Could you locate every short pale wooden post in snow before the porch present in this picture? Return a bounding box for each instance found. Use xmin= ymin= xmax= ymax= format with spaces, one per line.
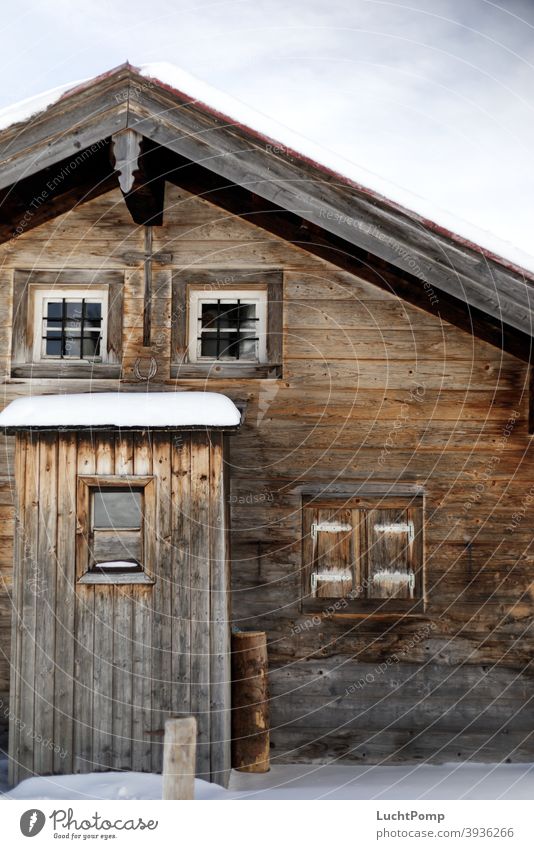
xmin=163 ymin=716 xmax=197 ymax=799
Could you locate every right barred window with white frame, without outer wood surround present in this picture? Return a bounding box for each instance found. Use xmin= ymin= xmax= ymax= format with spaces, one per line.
xmin=189 ymin=289 xmax=267 ymax=363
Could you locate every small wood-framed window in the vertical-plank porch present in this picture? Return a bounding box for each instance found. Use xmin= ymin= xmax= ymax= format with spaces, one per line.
xmin=77 ymin=476 xmax=154 ymax=584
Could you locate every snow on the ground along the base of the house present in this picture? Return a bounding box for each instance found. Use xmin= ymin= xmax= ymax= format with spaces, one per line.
xmin=0 ymin=761 xmax=534 ymax=800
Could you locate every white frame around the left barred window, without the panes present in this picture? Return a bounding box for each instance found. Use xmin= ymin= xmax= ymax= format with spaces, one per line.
xmin=33 ymin=287 xmax=108 ymax=363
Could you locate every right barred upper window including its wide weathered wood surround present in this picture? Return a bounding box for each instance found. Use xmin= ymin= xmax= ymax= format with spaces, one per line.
xmin=171 ymin=270 xmax=283 ymax=378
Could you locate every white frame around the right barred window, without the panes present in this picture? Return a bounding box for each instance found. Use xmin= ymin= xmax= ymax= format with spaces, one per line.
xmin=188 ymin=288 xmax=267 ymax=366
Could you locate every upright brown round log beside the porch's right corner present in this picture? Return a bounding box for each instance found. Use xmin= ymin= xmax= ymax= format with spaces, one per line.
xmin=232 ymin=631 xmax=269 ymax=772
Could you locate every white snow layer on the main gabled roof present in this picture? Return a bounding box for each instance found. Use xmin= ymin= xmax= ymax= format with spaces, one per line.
xmin=0 ymin=62 xmax=534 ymax=272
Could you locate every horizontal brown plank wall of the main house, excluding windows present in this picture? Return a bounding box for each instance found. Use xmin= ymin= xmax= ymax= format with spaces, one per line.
xmin=0 ymin=187 xmax=534 ymax=761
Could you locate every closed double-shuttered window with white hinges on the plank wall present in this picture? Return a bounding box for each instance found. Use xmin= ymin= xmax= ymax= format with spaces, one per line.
xmin=302 ymin=496 xmax=423 ymax=612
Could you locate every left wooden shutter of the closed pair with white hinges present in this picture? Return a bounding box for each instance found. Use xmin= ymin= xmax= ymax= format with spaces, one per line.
xmin=304 ymin=507 xmax=355 ymax=598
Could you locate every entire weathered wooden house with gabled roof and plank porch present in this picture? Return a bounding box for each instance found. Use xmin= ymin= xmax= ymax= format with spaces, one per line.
xmin=0 ymin=65 xmax=534 ymax=780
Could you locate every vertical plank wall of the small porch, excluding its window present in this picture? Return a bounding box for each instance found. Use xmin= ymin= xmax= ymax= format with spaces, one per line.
xmin=10 ymin=433 xmax=229 ymax=782
